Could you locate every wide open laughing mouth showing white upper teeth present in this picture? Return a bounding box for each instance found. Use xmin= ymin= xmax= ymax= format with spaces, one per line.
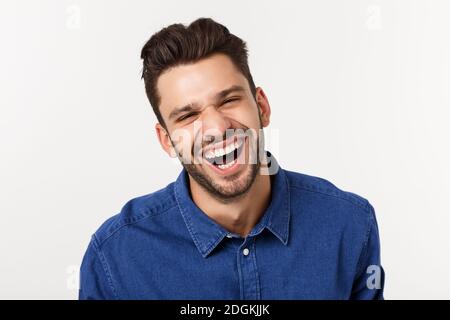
xmin=205 ymin=138 xmax=245 ymax=170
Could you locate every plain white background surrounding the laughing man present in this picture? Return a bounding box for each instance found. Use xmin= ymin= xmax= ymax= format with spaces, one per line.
xmin=0 ymin=0 xmax=450 ymax=299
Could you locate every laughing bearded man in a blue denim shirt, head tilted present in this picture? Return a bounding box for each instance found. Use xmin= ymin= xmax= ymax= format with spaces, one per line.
xmin=79 ymin=18 xmax=384 ymax=299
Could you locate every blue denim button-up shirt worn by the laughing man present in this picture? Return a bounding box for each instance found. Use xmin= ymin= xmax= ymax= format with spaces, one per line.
xmin=79 ymin=158 xmax=384 ymax=299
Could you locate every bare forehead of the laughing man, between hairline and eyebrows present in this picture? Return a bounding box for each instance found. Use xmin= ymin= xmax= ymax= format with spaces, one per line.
xmin=157 ymin=54 xmax=249 ymax=116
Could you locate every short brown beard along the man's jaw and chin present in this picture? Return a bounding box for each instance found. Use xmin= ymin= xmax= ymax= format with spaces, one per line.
xmin=173 ymin=125 xmax=264 ymax=203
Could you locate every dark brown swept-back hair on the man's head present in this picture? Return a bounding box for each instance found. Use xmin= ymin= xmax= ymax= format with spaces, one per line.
xmin=141 ymin=18 xmax=256 ymax=126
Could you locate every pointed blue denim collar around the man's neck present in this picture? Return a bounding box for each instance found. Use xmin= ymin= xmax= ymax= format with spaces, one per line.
xmin=174 ymin=152 xmax=290 ymax=258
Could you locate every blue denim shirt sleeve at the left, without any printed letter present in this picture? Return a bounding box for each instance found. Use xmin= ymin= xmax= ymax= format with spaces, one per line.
xmin=78 ymin=235 xmax=116 ymax=300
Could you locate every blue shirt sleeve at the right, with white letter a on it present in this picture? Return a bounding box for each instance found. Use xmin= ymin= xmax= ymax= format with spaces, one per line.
xmin=351 ymin=203 xmax=385 ymax=300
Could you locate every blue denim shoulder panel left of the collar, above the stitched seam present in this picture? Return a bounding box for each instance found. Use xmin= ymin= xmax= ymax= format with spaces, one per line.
xmin=94 ymin=183 xmax=177 ymax=246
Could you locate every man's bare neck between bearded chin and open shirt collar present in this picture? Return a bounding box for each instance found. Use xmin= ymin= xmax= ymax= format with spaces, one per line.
xmin=189 ymin=172 xmax=271 ymax=237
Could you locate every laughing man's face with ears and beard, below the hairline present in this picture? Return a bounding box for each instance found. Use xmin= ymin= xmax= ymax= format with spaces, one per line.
xmin=156 ymin=54 xmax=270 ymax=201
